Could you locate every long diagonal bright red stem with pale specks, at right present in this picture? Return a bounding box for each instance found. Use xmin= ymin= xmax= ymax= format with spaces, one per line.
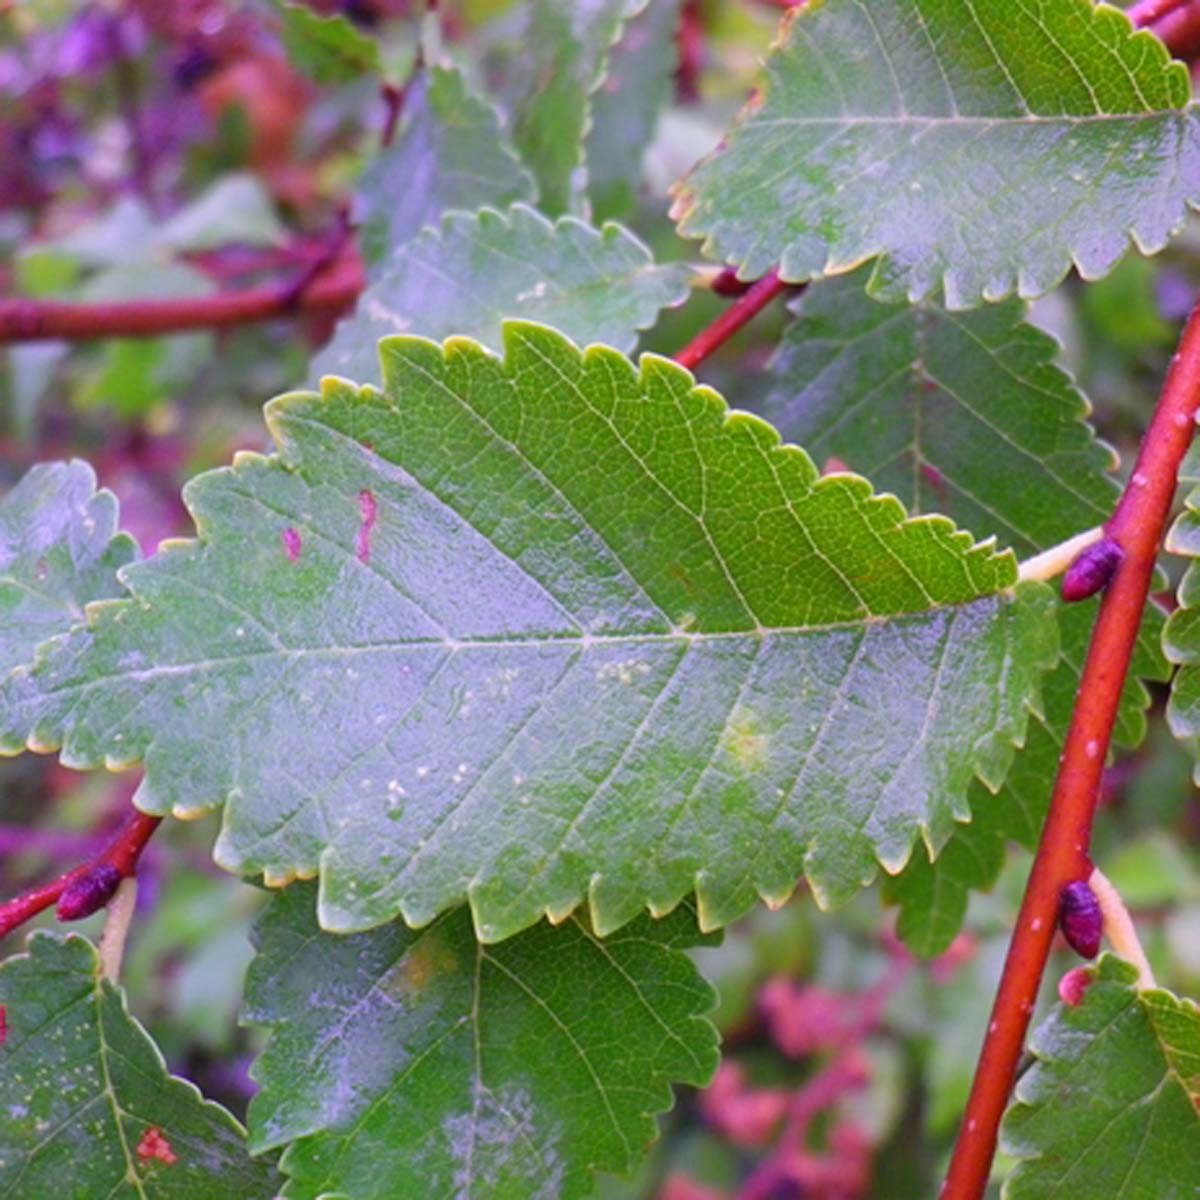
xmin=942 ymin=295 xmax=1200 ymax=1200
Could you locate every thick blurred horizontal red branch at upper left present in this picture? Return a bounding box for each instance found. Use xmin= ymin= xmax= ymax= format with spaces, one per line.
xmin=0 ymin=254 xmax=364 ymax=344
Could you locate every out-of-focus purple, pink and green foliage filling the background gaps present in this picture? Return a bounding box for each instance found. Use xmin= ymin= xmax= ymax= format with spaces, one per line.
xmin=0 ymin=0 xmax=1200 ymax=1200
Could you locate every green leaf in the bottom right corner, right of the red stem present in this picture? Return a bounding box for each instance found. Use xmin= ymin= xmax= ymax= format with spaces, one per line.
xmin=1001 ymin=955 xmax=1200 ymax=1200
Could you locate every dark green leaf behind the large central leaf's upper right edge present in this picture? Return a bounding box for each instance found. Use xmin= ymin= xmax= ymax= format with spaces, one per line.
xmin=763 ymin=268 xmax=1116 ymax=558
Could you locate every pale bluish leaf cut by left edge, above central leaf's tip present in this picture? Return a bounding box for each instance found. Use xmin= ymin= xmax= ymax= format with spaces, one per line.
xmin=0 ymin=460 xmax=137 ymax=676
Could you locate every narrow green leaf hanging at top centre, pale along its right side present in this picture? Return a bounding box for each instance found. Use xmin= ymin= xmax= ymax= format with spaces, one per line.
xmin=512 ymin=0 xmax=648 ymax=217
